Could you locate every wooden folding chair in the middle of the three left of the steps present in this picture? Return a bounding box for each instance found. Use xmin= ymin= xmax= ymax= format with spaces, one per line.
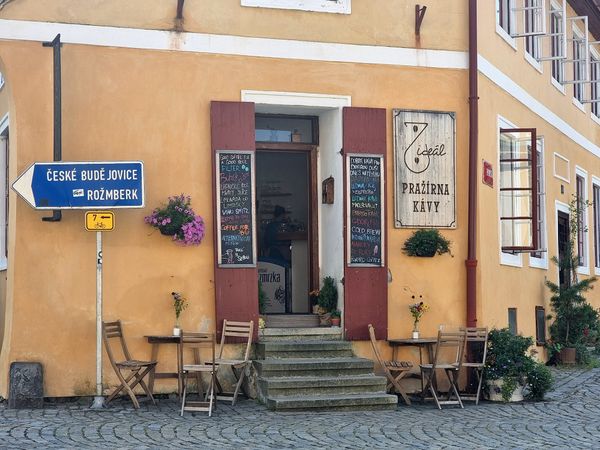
xmin=178 ymin=331 xmax=217 ymax=417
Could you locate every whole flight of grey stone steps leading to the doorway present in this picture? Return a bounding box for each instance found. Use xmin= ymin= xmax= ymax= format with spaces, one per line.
xmin=253 ymin=338 xmax=398 ymax=411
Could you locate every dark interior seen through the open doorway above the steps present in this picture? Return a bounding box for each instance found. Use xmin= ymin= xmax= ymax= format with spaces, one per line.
xmin=256 ymin=149 xmax=311 ymax=314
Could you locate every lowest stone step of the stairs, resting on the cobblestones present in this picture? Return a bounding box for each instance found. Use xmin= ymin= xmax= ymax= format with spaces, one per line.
xmin=267 ymin=393 xmax=398 ymax=411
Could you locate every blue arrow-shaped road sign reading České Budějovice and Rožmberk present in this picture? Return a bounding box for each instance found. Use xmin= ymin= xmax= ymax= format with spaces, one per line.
xmin=12 ymin=161 xmax=144 ymax=209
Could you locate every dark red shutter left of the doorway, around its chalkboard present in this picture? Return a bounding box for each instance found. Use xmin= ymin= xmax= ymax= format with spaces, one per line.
xmin=210 ymin=102 xmax=258 ymax=340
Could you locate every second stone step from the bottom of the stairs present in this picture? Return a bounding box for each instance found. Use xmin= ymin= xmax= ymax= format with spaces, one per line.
xmin=258 ymin=374 xmax=386 ymax=397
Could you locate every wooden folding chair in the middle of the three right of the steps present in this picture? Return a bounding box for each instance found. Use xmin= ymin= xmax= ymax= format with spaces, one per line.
xmin=420 ymin=330 xmax=465 ymax=409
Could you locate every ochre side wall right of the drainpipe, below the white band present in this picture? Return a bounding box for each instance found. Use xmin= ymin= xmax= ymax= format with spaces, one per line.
xmin=478 ymin=72 xmax=600 ymax=351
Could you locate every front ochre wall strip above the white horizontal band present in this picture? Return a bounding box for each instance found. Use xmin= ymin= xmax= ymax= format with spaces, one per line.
xmin=0 ymin=0 xmax=468 ymax=50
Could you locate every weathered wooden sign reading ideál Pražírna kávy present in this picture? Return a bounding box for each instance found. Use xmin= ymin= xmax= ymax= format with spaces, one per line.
xmin=393 ymin=109 xmax=456 ymax=228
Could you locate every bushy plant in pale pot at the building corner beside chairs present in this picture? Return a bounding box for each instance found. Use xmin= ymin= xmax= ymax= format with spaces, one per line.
xmin=484 ymin=328 xmax=553 ymax=402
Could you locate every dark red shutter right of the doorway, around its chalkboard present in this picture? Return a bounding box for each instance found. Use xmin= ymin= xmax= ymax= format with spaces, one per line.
xmin=343 ymin=108 xmax=388 ymax=340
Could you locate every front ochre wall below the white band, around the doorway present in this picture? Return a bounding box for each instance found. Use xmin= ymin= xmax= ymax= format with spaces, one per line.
xmin=0 ymin=42 xmax=468 ymax=396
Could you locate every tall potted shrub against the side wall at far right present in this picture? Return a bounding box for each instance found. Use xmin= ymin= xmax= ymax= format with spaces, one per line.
xmin=546 ymin=199 xmax=598 ymax=364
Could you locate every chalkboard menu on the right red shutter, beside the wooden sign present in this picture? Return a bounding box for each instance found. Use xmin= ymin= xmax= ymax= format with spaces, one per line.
xmin=347 ymin=154 xmax=384 ymax=267
